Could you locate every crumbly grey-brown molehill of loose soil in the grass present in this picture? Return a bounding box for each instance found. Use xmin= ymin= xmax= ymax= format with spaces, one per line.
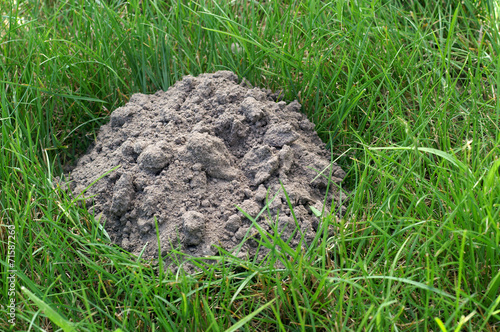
xmin=70 ymin=71 xmax=346 ymax=266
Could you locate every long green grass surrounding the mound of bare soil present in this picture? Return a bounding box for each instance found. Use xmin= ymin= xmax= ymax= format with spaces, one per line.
xmin=0 ymin=0 xmax=500 ymax=331
